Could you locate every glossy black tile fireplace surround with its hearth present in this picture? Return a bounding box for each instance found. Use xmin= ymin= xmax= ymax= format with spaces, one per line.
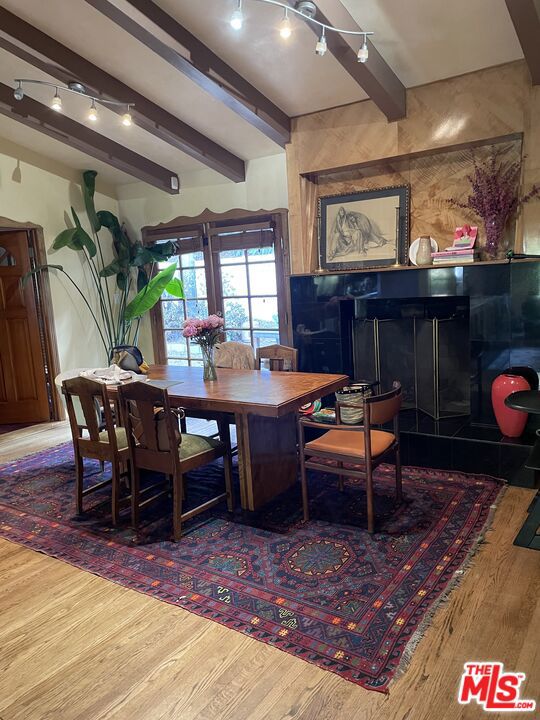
xmin=290 ymin=261 xmax=540 ymax=485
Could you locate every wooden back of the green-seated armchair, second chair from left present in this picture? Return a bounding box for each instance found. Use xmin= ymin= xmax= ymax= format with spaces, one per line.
xmin=118 ymin=382 xmax=181 ymax=475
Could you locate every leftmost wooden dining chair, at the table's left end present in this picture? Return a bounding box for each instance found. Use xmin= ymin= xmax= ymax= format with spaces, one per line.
xmin=62 ymin=377 xmax=129 ymax=525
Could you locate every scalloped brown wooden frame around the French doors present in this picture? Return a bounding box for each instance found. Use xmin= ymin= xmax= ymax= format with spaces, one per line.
xmin=141 ymin=208 xmax=293 ymax=365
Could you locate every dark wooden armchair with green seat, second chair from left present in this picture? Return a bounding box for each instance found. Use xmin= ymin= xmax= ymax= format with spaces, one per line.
xmin=118 ymin=383 xmax=234 ymax=542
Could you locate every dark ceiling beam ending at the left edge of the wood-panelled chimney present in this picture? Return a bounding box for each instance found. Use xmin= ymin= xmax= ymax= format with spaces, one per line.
xmin=86 ymin=0 xmax=291 ymax=147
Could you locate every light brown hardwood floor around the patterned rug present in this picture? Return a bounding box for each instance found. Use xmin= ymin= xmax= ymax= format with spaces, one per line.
xmin=0 ymin=423 xmax=540 ymax=720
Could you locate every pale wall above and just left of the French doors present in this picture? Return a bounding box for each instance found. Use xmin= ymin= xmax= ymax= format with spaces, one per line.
xmin=118 ymin=153 xmax=288 ymax=362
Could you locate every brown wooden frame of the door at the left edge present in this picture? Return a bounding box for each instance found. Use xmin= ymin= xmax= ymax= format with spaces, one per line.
xmin=0 ymin=217 xmax=65 ymax=420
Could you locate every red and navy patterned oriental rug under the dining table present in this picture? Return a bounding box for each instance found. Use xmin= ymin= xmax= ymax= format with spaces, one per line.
xmin=0 ymin=445 xmax=503 ymax=692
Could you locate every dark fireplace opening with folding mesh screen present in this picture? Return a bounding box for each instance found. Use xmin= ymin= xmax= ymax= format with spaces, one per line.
xmin=352 ymin=297 xmax=471 ymax=420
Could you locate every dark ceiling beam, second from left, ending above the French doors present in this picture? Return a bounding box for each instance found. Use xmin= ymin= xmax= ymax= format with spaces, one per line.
xmin=0 ymin=7 xmax=246 ymax=182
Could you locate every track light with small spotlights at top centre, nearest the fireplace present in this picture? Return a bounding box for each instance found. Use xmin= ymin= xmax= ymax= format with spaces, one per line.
xmin=226 ymin=0 xmax=373 ymax=63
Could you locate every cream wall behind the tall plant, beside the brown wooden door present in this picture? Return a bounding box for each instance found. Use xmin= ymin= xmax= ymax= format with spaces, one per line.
xmin=0 ymin=138 xmax=118 ymax=370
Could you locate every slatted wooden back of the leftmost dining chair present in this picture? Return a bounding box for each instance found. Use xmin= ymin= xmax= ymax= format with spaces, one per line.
xmin=62 ymin=377 xmax=117 ymax=454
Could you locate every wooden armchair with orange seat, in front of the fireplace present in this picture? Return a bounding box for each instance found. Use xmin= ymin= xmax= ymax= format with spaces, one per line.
xmin=298 ymin=381 xmax=402 ymax=533
